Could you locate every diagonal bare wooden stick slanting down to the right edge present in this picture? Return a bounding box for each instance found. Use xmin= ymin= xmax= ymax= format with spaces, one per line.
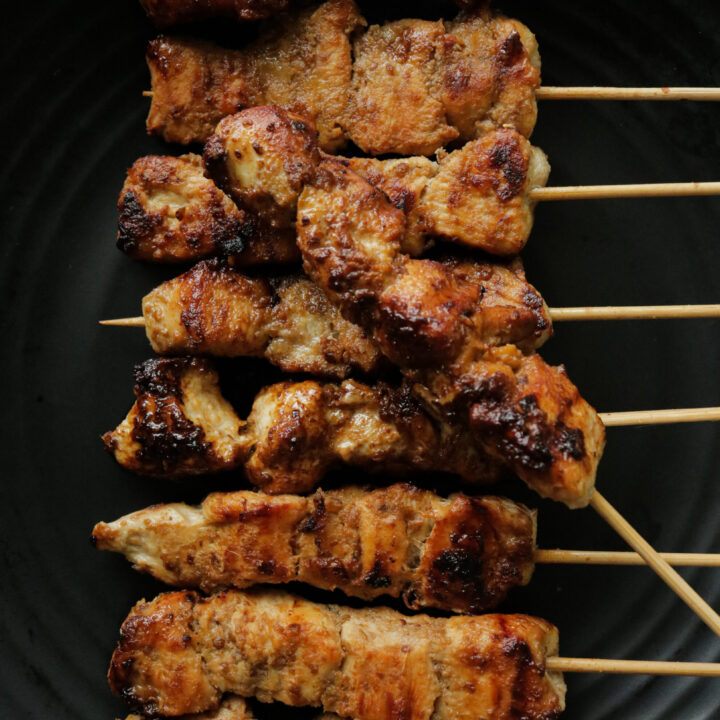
xmin=590 ymin=490 xmax=720 ymax=636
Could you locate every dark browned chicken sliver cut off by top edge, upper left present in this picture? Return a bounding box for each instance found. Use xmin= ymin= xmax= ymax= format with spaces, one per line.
xmin=140 ymin=0 xmax=288 ymax=27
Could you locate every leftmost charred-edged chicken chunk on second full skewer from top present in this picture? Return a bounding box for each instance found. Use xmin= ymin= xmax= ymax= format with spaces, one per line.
xmin=117 ymin=154 xmax=300 ymax=266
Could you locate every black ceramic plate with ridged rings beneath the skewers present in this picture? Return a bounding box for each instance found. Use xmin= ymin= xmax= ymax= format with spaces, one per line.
xmin=0 ymin=0 xmax=720 ymax=720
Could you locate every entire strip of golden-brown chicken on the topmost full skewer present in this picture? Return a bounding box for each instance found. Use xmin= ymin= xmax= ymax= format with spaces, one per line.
xmin=147 ymin=0 xmax=540 ymax=155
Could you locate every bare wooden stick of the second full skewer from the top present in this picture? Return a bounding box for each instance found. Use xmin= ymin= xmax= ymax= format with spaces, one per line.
xmin=530 ymin=182 xmax=720 ymax=201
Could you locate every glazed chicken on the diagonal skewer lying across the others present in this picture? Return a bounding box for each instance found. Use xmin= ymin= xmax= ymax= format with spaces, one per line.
xmin=298 ymin=160 xmax=605 ymax=507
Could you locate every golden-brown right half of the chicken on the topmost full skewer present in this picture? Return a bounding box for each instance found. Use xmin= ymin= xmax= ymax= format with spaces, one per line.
xmin=343 ymin=10 xmax=540 ymax=155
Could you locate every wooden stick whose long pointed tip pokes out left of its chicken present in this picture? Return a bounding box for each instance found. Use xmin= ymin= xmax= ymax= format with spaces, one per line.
xmin=100 ymin=303 xmax=720 ymax=327
